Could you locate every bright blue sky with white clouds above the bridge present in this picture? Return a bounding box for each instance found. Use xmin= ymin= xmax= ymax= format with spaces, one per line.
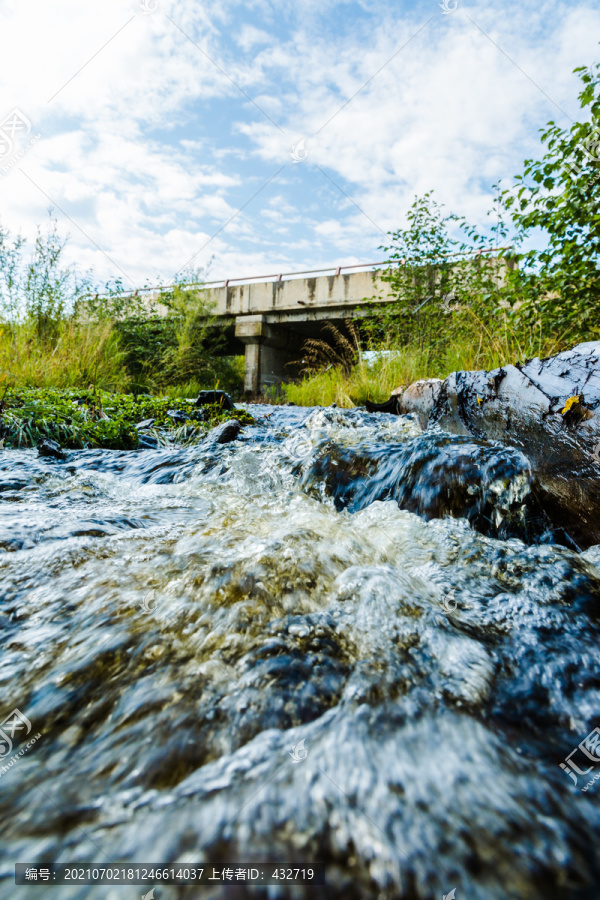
xmin=0 ymin=0 xmax=600 ymax=286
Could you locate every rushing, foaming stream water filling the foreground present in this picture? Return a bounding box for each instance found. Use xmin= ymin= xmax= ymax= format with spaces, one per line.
xmin=0 ymin=407 xmax=600 ymax=900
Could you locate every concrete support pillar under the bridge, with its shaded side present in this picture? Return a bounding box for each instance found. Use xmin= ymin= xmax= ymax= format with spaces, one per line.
xmin=235 ymin=316 xmax=304 ymax=397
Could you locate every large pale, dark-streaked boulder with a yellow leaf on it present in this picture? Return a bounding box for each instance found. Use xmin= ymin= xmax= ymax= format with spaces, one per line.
xmin=428 ymin=341 xmax=600 ymax=547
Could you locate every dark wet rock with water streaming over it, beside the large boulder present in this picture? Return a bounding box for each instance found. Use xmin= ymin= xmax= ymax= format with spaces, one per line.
xmin=304 ymin=432 xmax=556 ymax=546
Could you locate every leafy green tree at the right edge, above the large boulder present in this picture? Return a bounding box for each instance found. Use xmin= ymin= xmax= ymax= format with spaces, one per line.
xmin=503 ymin=57 xmax=600 ymax=349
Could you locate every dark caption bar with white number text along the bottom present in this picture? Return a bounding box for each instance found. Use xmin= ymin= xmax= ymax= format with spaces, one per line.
xmin=15 ymin=863 xmax=325 ymax=887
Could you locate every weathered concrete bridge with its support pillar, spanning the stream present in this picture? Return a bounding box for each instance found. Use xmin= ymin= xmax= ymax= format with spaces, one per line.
xmin=130 ymin=247 xmax=509 ymax=396
